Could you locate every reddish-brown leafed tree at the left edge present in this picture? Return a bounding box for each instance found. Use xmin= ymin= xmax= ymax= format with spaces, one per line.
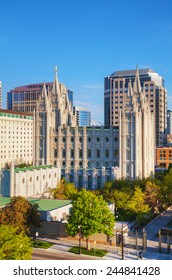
xmin=0 ymin=196 xmax=40 ymax=233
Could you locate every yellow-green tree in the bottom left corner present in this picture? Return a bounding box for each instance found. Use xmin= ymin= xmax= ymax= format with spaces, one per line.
xmin=0 ymin=225 xmax=32 ymax=260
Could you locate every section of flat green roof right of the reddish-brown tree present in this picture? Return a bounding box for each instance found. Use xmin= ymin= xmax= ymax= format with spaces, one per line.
xmin=29 ymin=198 xmax=72 ymax=211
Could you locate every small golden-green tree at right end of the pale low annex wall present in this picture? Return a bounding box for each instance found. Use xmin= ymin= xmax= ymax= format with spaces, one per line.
xmin=50 ymin=178 xmax=77 ymax=199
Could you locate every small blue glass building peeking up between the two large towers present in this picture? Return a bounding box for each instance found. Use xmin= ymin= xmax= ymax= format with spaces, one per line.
xmin=74 ymin=106 xmax=91 ymax=126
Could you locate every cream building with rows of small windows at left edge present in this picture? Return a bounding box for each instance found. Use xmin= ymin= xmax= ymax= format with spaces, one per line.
xmin=0 ymin=109 xmax=33 ymax=170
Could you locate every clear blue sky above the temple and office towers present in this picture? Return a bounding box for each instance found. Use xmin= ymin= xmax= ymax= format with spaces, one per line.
xmin=0 ymin=0 xmax=172 ymax=122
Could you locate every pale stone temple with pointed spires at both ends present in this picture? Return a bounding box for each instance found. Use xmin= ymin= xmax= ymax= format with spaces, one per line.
xmin=33 ymin=67 xmax=155 ymax=189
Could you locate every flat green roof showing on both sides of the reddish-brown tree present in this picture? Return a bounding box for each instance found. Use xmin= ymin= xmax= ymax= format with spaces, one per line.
xmin=0 ymin=196 xmax=72 ymax=211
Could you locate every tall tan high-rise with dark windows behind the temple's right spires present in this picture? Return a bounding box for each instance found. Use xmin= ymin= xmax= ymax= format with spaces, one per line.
xmin=104 ymin=69 xmax=167 ymax=146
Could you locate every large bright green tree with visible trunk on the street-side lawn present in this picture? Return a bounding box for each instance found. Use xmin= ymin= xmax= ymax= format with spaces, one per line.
xmin=67 ymin=189 xmax=114 ymax=249
